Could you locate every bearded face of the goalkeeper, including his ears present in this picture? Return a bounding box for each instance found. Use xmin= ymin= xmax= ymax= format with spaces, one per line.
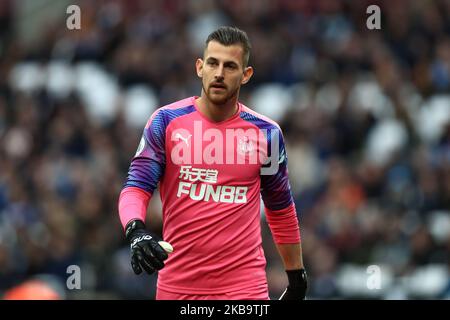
xmin=196 ymin=41 xmax=253 ymax=105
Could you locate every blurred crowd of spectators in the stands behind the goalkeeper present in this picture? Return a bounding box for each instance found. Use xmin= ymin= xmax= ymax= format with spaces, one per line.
xmin=0 ymin=0 xmax=450 ymax=299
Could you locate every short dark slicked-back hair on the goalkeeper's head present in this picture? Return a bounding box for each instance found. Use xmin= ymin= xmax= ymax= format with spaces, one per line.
xmin=206 ymin=26 xmax=252 ymax=68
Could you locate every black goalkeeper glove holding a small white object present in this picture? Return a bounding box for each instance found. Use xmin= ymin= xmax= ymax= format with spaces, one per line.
xmin=125 ymin=220 xmax=168 ymax=274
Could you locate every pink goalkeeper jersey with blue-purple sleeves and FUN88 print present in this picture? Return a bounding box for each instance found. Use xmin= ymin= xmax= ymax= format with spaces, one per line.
xmin=119 ymin=97 xmax=300 ymax=294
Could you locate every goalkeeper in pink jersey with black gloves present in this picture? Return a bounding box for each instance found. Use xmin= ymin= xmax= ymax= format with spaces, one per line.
xmin=119 ymin=27 xmax=307 ymax=300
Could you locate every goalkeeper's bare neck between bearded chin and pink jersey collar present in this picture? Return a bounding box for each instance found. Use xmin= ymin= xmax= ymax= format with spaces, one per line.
xmin=196 ymin=92 xmax=238 ymax=122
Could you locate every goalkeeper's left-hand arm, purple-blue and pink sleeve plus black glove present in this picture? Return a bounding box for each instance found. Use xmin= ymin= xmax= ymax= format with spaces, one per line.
xmin=118 ymin=111 xmax=168 ymax=274
